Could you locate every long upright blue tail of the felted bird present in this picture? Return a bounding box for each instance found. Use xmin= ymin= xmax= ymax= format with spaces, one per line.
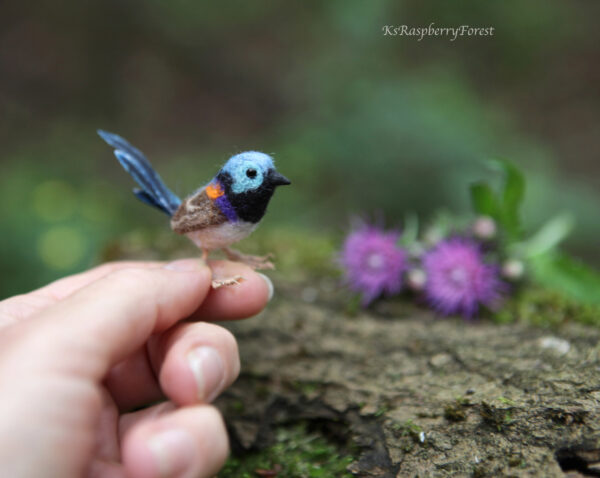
xmin=98 ymin=130 xmax=181 ymax=216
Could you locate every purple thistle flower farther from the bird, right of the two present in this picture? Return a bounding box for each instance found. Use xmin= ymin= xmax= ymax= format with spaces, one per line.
xmin=423 ymin=238 xmax=505 ymax=318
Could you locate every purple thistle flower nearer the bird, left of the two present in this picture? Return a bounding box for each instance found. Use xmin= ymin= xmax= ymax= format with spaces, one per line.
xmin=340 ymin=224 xmax=406 ymax=307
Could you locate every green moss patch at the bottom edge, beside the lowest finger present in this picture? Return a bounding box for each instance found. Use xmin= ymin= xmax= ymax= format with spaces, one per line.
xmin=218 ymin=424 xmax=354 ymax=478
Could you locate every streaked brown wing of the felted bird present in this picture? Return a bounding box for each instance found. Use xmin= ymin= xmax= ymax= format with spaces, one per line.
xmin=171 ymin=188 xmax=227 ymax=234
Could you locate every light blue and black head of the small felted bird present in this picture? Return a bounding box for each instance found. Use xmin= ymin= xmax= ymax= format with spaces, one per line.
xmin=217 ymin=151 xmax=290 ymax=222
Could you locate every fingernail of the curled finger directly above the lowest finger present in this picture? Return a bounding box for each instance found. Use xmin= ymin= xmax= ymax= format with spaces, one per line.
xmin=187 ymin=346 xmax=225 ymax=402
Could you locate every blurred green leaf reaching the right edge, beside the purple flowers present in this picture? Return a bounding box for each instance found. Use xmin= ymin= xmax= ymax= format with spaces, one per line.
xmin=530 ymin=252 xmax=600 ymax=304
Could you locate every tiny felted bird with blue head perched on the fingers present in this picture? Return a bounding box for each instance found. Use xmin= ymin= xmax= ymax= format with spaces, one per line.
xmin=98 ymin=130 xmax=290 ymax=288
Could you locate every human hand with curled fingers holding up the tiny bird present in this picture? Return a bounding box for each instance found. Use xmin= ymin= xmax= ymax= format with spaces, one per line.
xmin=0 ymin=259 xmax=272 ymax=478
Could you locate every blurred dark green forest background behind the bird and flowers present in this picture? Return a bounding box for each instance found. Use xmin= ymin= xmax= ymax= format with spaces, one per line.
xmin=0 ymin=0 xmax=600 ymax=297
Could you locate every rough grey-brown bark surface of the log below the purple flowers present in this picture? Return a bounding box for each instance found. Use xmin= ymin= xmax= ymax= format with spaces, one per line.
xmin=217 ymin=286 xmax=600 ymax=477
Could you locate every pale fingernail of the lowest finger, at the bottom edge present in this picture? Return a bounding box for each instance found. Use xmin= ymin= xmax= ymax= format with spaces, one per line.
xmin=148 ymin=428 xmax=196 ymax=478
